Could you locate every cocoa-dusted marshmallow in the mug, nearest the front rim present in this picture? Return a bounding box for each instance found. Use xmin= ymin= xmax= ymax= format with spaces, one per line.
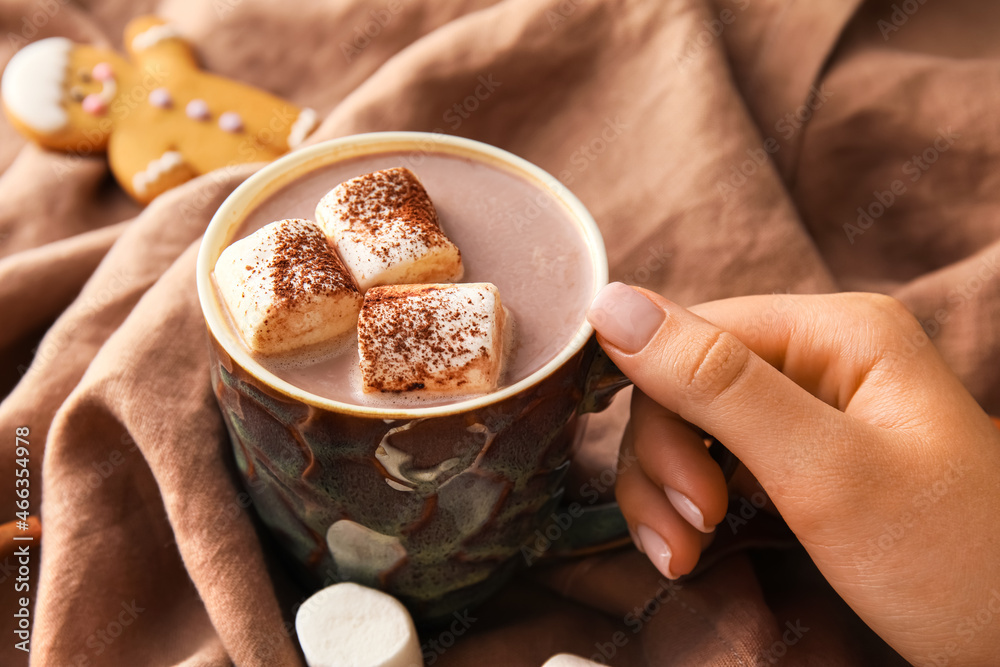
xmin=358 ymin=283 xmax=506 ymax=393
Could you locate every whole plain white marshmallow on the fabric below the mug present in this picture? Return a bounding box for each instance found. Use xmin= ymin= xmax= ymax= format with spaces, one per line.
xmin=295 ymin=583 xmax=424 ymax=667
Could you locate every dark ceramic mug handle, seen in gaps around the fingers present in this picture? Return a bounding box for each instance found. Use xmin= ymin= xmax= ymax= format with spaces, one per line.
xmin=542 ymin=338 xmax=739 ymax=560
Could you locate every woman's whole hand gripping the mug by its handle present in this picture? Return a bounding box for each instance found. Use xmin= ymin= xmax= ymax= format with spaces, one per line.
xmin=589 ymin=283 xmax=1000 ymax=665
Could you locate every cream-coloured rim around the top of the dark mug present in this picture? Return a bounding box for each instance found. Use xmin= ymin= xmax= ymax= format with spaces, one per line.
xmin=196 ymin=132 xmax=608 ymax=419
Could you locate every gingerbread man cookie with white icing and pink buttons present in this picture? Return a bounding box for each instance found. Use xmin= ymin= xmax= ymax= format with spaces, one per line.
xmin=0 ymin=17 xmax=317 ymax=203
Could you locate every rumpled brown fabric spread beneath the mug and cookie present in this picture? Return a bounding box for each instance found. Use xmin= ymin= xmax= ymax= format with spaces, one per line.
xmin=0 ymin=0 xmax=1000 ymax=666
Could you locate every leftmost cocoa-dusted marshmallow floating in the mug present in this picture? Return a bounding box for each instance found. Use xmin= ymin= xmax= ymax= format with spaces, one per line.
xmin=215 ymin=220 xmax=362 ymax=354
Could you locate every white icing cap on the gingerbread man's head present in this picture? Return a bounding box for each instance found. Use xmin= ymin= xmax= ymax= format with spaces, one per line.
xmin=0 ymin=37 xmax=73 ymax=134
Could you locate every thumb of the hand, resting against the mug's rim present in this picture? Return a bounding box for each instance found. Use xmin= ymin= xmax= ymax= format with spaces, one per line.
xmin=587 ymin=283 xmax=871 ymax=489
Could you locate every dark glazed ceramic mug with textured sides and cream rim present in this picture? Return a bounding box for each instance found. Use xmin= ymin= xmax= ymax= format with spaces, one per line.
xmin=197 ymin=132 xmax=628 ymax=623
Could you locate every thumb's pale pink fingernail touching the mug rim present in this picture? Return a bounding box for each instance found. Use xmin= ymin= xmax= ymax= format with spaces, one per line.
xmin=587 ymin=283 xmax=665 ymax=354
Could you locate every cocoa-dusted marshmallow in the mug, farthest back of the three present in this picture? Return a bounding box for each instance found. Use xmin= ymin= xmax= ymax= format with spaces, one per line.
xmin=316 ymin=168 xmax=463 ymax=292
